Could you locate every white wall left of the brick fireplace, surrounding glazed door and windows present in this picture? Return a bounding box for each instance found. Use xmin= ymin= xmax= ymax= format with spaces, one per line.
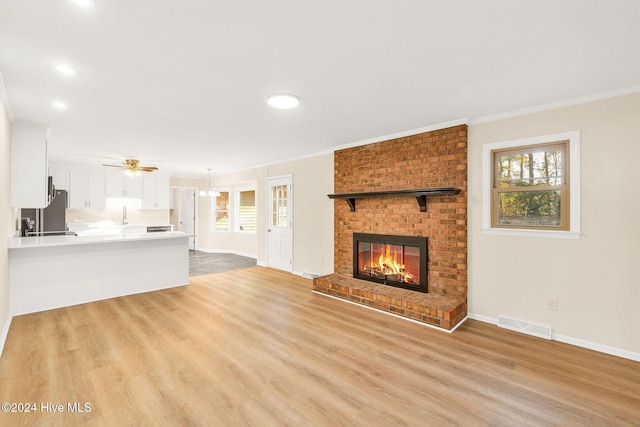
xmin=198 ymin=153 xmax=333 ymax=274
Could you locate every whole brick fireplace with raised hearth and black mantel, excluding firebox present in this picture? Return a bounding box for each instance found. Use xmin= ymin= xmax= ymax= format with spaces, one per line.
xmin=313 ymin=125 xmax=467 ymax=329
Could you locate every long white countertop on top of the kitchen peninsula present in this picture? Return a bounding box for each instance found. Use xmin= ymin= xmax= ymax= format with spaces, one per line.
xmin=8 ymin=231 xmax=192 ymax=249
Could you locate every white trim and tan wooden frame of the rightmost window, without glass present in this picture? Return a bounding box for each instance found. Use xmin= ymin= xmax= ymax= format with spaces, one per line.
xmin=482 ymin=131 xmax=580 ymax=239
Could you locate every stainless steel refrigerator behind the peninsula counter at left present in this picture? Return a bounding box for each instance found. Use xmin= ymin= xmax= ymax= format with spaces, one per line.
xmin=20 ymin=190 xmax=67 ymax=235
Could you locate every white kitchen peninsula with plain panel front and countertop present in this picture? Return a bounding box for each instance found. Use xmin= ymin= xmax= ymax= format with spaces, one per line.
xmin=8 ymin=232 xmax=191 ymax=316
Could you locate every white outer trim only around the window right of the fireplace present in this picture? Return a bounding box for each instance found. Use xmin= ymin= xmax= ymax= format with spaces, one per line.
xmin=482 ymin=131 xmax=580 ymax=239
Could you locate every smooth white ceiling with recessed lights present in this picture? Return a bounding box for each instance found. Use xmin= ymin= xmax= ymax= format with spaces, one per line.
xmin=0 ymin=0 xmax=640 ymax=177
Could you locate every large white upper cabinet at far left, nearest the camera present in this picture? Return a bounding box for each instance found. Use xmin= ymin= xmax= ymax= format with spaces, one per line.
xmin=11 ymin=122 xmax=50 ymax=208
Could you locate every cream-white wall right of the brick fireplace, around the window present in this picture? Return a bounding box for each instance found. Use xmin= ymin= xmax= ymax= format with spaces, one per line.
xmin=469 ymin=94 xmax=640 ymax=354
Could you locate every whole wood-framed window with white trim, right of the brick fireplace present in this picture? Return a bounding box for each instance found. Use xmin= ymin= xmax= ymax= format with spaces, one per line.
xmin=483 ymin=132 xmax=580 ymax=238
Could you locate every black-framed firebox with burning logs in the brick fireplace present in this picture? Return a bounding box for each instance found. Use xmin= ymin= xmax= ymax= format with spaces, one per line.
xmin=353 ymin=233 xmax=428 ymax=292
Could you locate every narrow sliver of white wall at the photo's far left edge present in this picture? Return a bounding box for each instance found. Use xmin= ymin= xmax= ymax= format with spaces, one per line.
xmin=0 ymin=100 xmax=11 ymax=354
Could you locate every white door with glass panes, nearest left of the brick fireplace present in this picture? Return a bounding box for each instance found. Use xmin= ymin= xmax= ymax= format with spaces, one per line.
xmin=267 ymin=176 xmax=293 ymax=272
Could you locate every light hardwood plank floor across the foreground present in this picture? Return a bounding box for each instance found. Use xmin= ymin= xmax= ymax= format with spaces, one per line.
xmin=0 ymin=267 xmax=640 ymax=426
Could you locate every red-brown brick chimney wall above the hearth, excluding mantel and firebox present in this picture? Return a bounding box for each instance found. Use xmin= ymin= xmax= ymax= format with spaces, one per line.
xmin=334 ymin=125 xmax=467 ymax=298
